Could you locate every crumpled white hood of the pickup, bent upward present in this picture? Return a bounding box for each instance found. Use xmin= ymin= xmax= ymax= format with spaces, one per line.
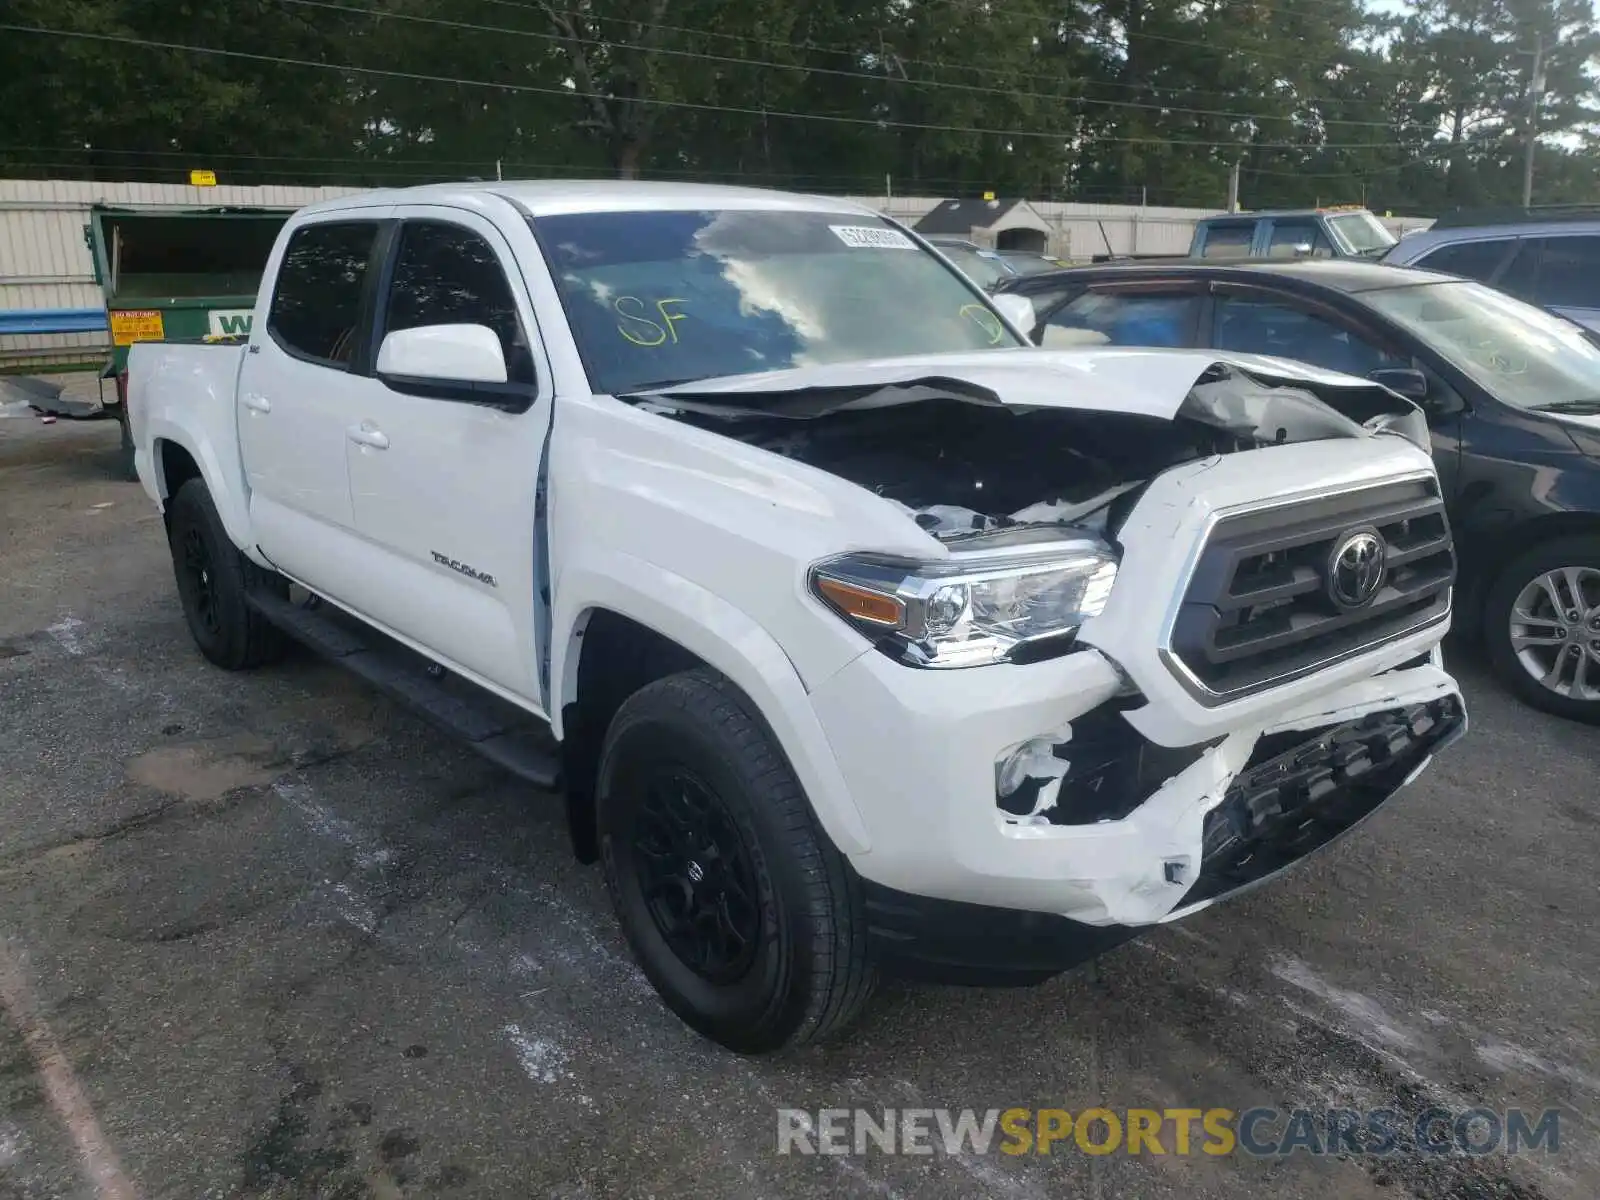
xmin=636 ymin=347 xmax=1418 ymax=432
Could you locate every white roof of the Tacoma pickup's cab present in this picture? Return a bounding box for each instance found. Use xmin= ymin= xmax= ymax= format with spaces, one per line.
xmin=304 ymin=179 xmax=878 ymax=218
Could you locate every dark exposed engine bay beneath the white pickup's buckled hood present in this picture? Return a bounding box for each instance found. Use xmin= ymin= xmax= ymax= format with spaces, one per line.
xmin=650 ymin=365 xmax=1414 ymax=542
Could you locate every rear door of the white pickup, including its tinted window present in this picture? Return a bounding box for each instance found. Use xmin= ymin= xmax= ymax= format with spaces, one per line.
xmin=238 ymin=221 xmax=382 ymax=598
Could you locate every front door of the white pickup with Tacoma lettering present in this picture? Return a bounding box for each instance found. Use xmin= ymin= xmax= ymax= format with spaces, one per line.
xmin=341 ymin=208 xmax=550 ymax=710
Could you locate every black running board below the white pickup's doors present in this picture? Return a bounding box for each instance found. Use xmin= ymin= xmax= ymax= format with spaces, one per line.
xmin=250 ymin=592 xmax=562 ymax=790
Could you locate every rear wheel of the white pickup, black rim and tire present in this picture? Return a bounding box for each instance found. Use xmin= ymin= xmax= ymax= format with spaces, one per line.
xmin=166 ymin=480 xmax=288 ymax=670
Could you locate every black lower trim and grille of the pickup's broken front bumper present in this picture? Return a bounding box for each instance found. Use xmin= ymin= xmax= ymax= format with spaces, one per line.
xmin=862 ymin=694 xmax=1467 ymax=986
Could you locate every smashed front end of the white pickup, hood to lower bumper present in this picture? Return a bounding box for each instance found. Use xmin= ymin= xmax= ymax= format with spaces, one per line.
xmin=640 ymin=352 xmax=1466 ymax=982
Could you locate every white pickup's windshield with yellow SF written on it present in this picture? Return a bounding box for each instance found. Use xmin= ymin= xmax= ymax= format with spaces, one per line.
xmin=533 ymin=210 xmax=1026 ymax=395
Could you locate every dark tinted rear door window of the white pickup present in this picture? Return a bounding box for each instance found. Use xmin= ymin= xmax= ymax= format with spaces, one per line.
xmin=267 ymin=221 xmax=378 ymax=371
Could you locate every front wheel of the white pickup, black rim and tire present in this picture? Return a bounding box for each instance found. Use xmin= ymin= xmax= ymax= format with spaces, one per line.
xmin=595 ymin=669 xmax=874 ymax=1054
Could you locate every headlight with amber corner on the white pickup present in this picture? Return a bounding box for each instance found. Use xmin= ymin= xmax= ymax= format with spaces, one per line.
xmin=811 ymin=530 xmax=1117 ymax=667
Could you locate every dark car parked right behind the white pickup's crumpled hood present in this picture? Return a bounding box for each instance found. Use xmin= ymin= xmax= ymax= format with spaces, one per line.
xmin=1000 ymin=259 xmax=1600 ymax=723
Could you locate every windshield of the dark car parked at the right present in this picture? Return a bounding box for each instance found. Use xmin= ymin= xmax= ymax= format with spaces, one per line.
xmin=1363 ymin=282 xmax=1600 ymax=410
